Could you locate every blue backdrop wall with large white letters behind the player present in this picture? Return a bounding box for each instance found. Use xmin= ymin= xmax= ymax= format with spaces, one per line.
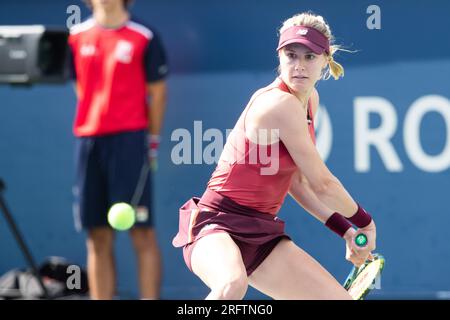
xmin=0 ymin=0 xmax=450 ymax=299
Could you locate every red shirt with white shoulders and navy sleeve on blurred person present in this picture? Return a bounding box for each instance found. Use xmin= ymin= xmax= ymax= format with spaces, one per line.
xmin=69 ymin=18 xmax=168 ymax=137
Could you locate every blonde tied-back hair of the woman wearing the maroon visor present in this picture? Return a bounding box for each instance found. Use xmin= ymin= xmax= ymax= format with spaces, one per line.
xmin=280 ymin=12 xmax=350 ymax=80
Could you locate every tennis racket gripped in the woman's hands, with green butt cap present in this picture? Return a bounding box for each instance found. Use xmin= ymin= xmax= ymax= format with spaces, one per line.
xmin=344 ymin=233 xmax=385 ymax=300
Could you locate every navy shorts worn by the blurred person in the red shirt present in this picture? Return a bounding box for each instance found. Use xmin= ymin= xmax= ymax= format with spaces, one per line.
xmin=73 ymin=130 xmax=153 ymax=231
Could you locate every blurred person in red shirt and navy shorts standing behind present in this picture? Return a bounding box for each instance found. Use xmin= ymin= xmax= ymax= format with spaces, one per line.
xmin=69 ymin=0 xmax=168 ymax=299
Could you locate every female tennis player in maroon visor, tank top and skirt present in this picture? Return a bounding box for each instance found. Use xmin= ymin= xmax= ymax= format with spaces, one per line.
xmin=173 ymin=13 xmax=376 ymax=299
